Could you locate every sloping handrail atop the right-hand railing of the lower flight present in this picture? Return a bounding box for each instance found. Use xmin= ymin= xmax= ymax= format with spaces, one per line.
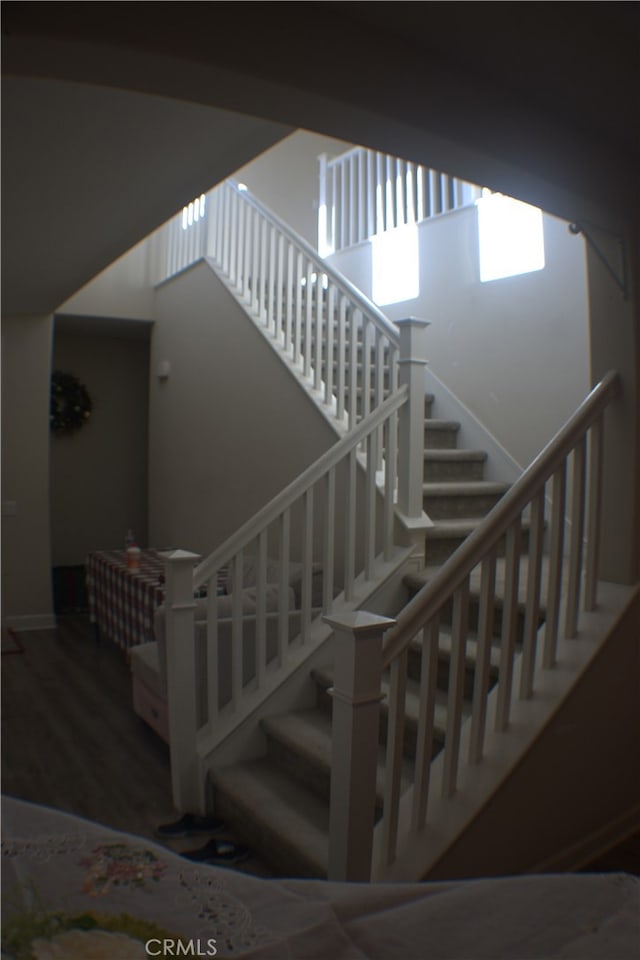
xmin=383 ymin=371 xmax=619 ymax=669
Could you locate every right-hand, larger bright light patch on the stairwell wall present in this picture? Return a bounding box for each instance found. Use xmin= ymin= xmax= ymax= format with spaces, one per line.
xmin=476 ymin=193 xmax=544 ymax=283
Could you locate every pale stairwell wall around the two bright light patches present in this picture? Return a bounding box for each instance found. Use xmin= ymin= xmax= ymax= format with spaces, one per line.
xmin=329 ymin=207 xmax=590 ymax=466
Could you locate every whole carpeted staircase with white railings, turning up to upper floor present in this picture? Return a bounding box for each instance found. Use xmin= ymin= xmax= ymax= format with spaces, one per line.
xmin=154 ymin=174 xmax=618 ymax=881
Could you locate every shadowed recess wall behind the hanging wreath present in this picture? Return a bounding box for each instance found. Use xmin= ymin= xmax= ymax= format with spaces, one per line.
xmin=50 ymin=321 xmax=149 ymax=566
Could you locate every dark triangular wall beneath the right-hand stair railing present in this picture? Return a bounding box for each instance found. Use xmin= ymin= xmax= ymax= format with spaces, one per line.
xmin=428 ymin=593 xmax=640 ymax=880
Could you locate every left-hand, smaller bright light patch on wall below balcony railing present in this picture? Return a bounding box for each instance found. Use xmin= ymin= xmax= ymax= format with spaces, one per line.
xmin=371 ymin=224 xmax=420 ymax=306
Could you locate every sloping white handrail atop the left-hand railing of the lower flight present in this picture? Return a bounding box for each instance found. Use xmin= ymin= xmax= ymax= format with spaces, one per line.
xmin=193 ymin=386 xmax=408 ymax=587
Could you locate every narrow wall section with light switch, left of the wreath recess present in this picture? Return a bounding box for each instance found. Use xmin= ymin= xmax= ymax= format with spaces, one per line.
xmin=2 ymin=315 xmax=53 ymax=627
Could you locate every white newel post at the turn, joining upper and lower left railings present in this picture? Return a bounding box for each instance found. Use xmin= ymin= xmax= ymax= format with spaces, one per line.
xmin=396 ymin=317 xmax=430 ymax=567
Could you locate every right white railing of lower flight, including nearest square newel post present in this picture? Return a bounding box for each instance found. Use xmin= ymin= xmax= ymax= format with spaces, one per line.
xmin=329 ymin=372 xmax=618 ymax=879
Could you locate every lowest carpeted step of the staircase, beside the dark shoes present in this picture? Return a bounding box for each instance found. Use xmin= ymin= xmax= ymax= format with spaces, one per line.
xmin=210 ymin=759 xmax=329 ymax=877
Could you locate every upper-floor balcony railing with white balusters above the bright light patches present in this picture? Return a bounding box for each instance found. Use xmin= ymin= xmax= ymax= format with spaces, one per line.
xmin=318 ymin=147 xmax=481 ymax=256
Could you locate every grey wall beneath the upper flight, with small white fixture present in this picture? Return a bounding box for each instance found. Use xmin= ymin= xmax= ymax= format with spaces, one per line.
xmin=149 ymin=263 xmax=336 ymax=555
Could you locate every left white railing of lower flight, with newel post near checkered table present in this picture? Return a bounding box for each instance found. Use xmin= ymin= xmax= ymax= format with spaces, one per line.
xmin=165 ymin=384 xmax=424 ymax=810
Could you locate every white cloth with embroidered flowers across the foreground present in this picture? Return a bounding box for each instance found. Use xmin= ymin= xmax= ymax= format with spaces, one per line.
xmin=2 ymin=798 xmax=640 ymax=960
